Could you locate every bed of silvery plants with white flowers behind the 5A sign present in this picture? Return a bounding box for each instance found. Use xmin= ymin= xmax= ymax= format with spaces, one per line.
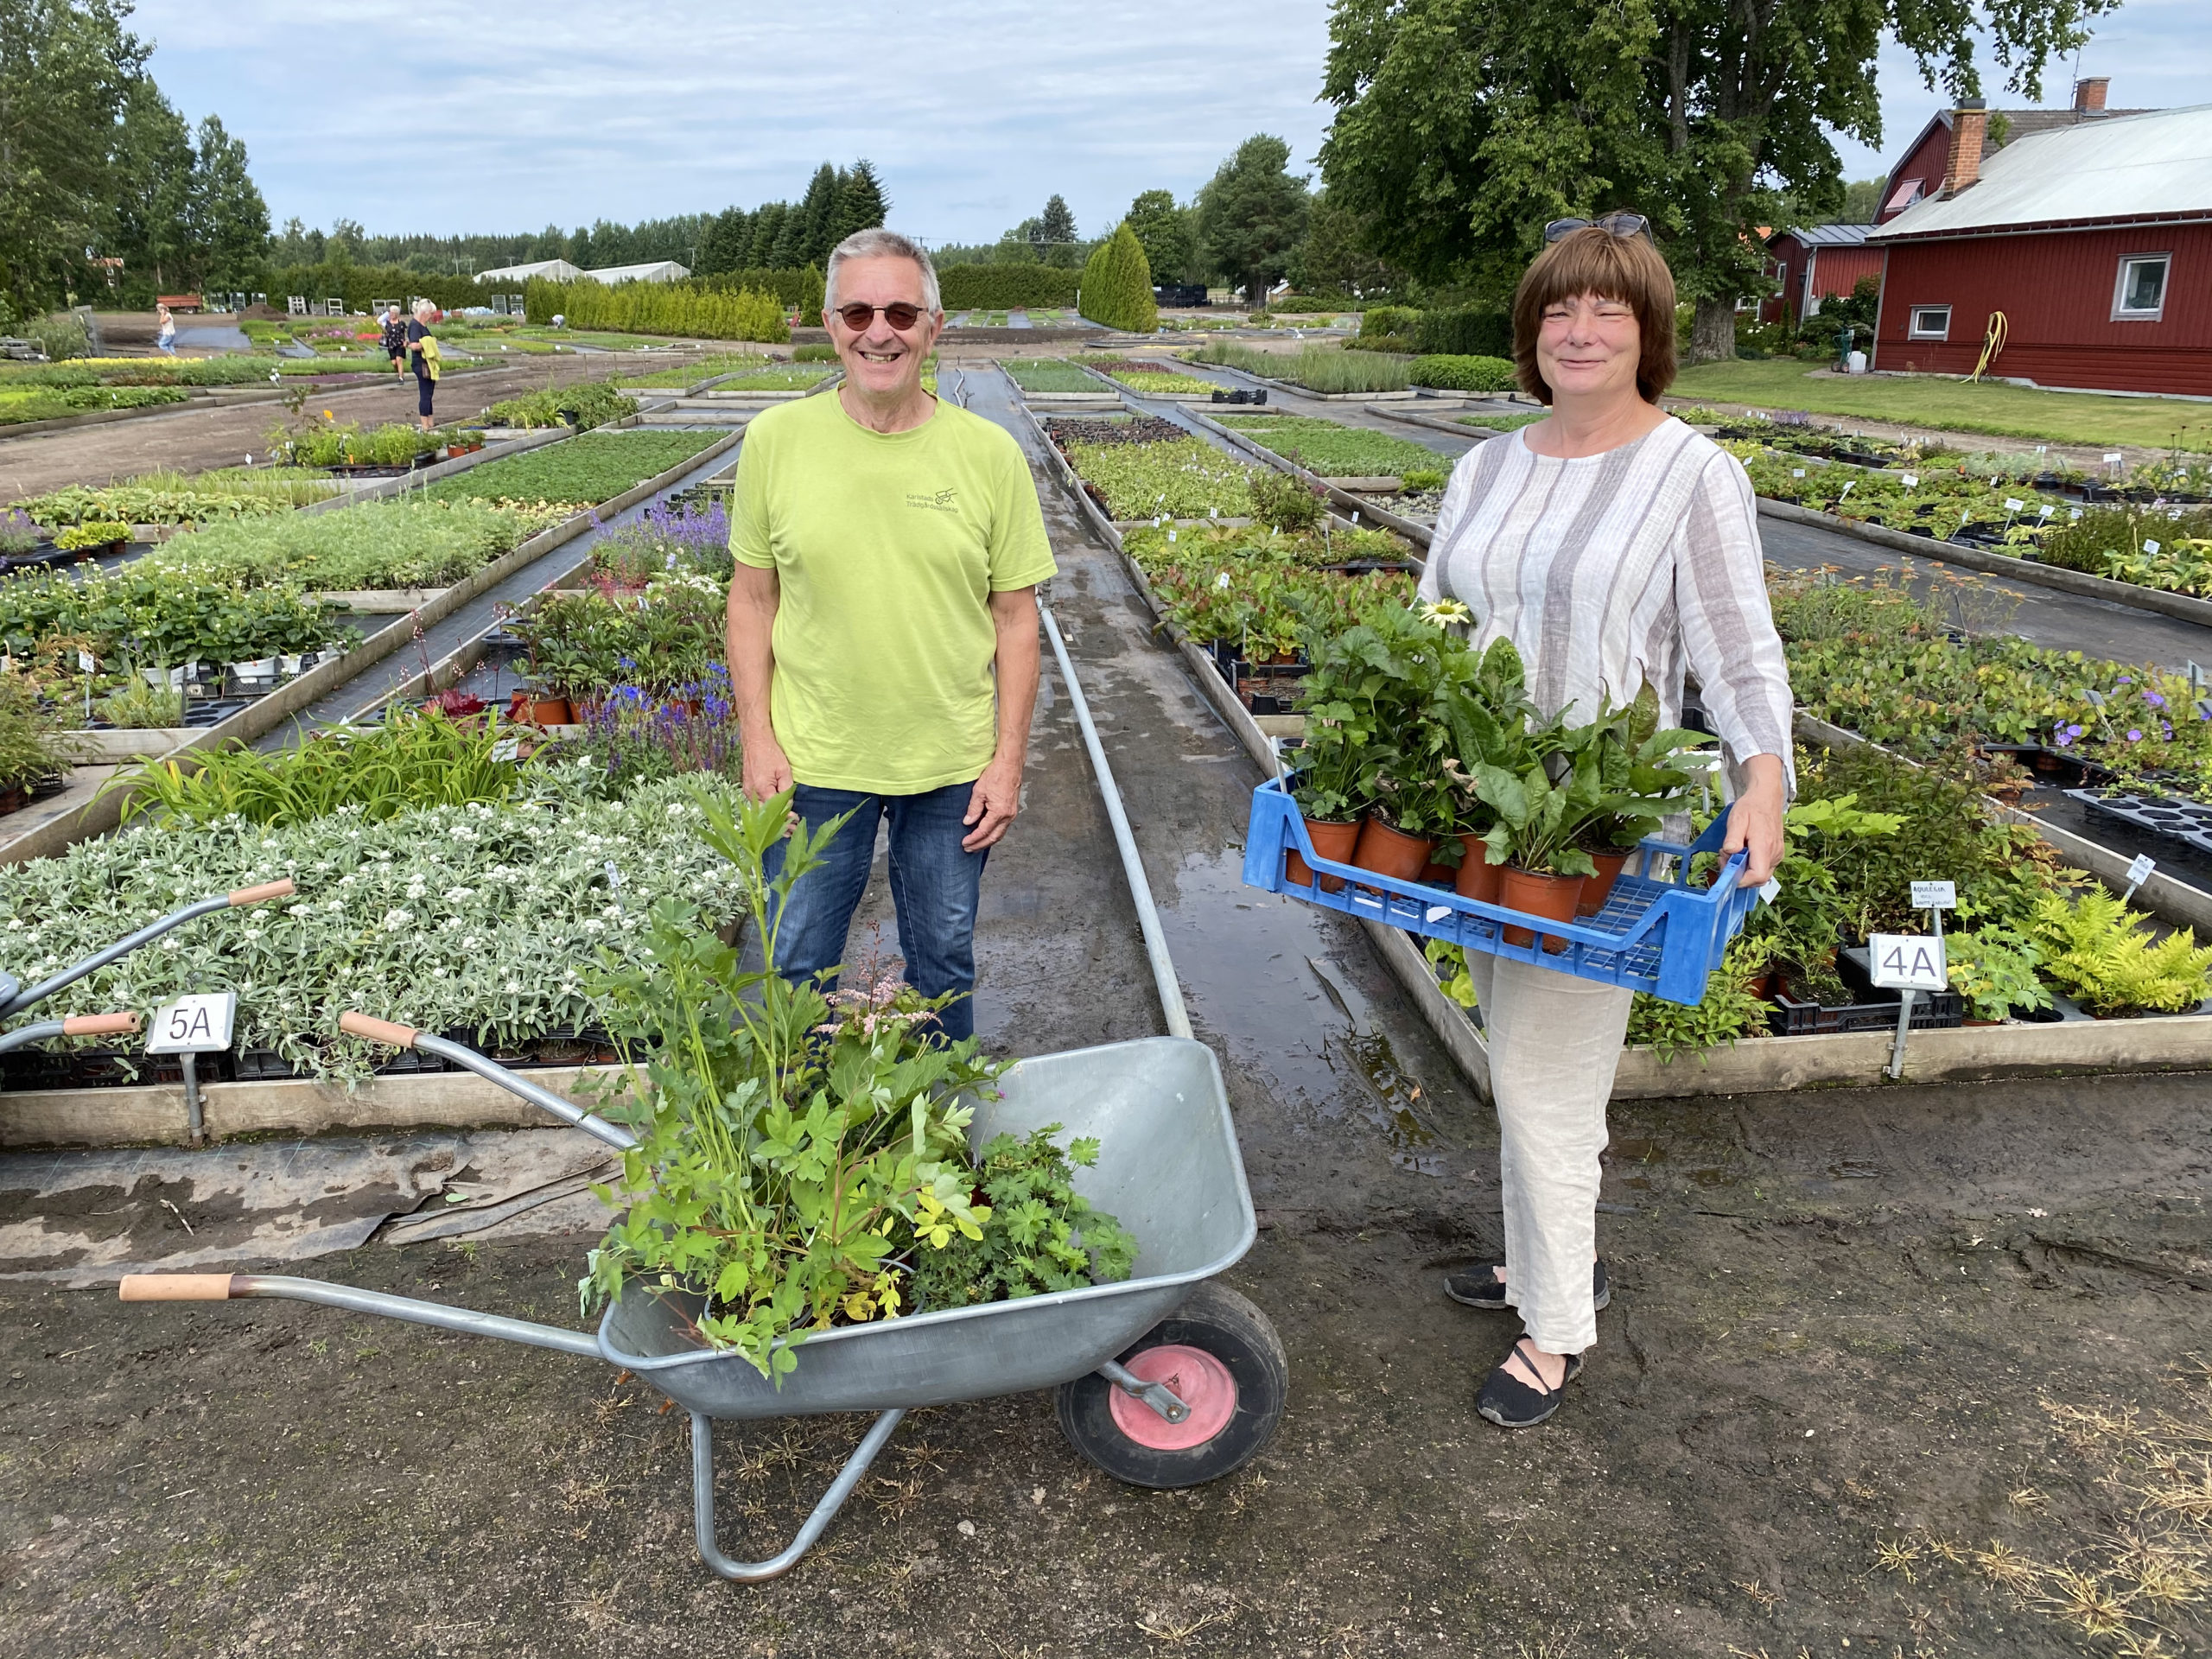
xmin=0 ymin=767 xmax=736 ymax=1082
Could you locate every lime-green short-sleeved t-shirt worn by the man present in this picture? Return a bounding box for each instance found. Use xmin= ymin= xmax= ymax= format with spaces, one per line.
xmin=730 ymin=391 xmax=1055 ymax=794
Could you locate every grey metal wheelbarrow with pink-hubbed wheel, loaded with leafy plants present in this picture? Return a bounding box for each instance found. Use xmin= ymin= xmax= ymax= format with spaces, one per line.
xmin=122 ymin=1013 xmax=1287 ymax=1584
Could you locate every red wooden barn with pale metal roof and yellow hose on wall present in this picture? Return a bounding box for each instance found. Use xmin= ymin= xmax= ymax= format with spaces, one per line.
xmin=1867 ymin=97 xmax=2212 ymax=396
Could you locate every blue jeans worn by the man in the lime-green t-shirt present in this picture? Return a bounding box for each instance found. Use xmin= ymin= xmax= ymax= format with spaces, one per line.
xmin=767 ymin=783 xmax=991 ymax=1042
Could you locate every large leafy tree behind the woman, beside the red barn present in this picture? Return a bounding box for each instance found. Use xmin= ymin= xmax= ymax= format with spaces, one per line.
xmin=1320 ymin=0 xmax=2119 ymax=359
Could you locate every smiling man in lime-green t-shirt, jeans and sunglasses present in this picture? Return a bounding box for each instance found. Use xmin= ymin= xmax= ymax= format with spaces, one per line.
xmin=730 ymin=230 xmax=1055 ymax=1039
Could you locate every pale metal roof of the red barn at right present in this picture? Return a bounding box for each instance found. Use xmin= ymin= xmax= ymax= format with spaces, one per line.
xmin=1869 ymin=104 xmax=2212 ymax=241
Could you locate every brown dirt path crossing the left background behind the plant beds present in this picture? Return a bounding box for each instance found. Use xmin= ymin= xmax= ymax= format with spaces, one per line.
xmin=0 ymin=352 xmax=671 ymax=502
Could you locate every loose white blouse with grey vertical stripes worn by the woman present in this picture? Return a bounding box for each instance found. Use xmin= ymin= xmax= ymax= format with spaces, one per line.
xmin=1421 ymin=418 xmax=1792 ymax=785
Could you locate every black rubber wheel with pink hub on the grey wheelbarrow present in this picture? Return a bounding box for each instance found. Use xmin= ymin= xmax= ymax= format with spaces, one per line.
xmin=1059 ymin=1283 xmax=1289 ymax=1491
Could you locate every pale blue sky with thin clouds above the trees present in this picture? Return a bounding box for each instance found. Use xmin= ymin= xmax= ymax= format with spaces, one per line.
xmin=133 ymin=0 xmax=2212 ymax=244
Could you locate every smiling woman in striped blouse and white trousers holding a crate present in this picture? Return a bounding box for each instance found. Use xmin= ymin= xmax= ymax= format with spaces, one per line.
xmin=1421 ymin=213 xmax=1792 ymax=1429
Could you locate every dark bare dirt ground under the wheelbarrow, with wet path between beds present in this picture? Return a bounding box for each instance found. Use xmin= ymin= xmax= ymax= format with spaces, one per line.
xmin=0 ymin=358 xmax=2212 ymax=1659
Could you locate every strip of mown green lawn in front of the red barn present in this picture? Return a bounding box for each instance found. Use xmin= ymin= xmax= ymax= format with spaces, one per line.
xmin=1668 ymin=359 xmax=2212 ymax=449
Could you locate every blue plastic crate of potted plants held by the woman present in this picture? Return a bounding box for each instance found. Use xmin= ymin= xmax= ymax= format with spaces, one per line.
xmin=1243 ymin=779 xmax=1758 ymax=1004
